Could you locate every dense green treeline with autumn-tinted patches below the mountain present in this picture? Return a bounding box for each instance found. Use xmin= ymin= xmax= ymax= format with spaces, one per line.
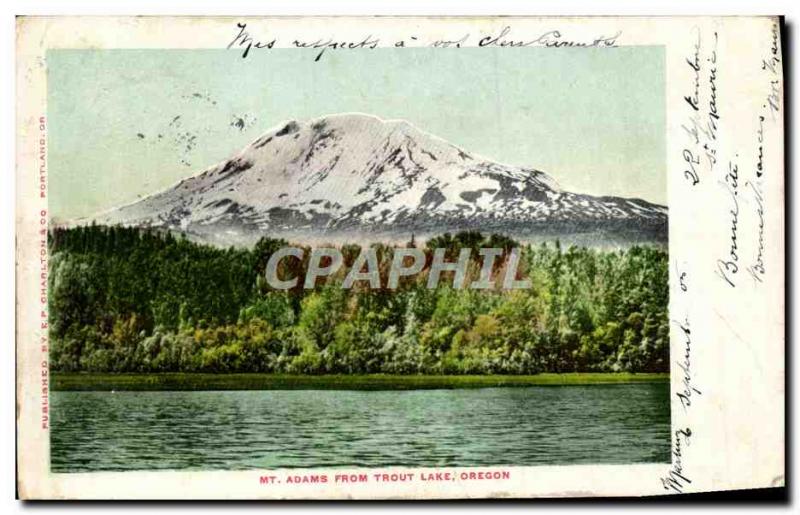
xmin=49 ymin=226 xmax=669 ymax=374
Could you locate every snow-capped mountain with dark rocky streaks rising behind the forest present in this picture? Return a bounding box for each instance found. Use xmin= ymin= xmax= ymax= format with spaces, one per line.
xmin=95 ymin=114 xmax=667 ymax=248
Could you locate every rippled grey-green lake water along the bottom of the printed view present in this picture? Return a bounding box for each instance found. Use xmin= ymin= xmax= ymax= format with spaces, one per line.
xmin=50 ymin=383 xmax=670 ymax=472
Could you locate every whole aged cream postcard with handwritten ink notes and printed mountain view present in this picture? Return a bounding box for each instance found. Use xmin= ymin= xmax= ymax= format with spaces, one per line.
xmin=16 ymin=17 xmax=786 ymax=499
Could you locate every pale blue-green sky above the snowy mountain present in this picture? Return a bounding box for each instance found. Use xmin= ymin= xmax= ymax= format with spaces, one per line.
xmin=47 ymin=47 xmax=667 ymax=220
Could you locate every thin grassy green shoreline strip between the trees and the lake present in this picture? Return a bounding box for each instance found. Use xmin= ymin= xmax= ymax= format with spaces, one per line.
xmin=50 ymin=372 xmax=669 ymax=392
